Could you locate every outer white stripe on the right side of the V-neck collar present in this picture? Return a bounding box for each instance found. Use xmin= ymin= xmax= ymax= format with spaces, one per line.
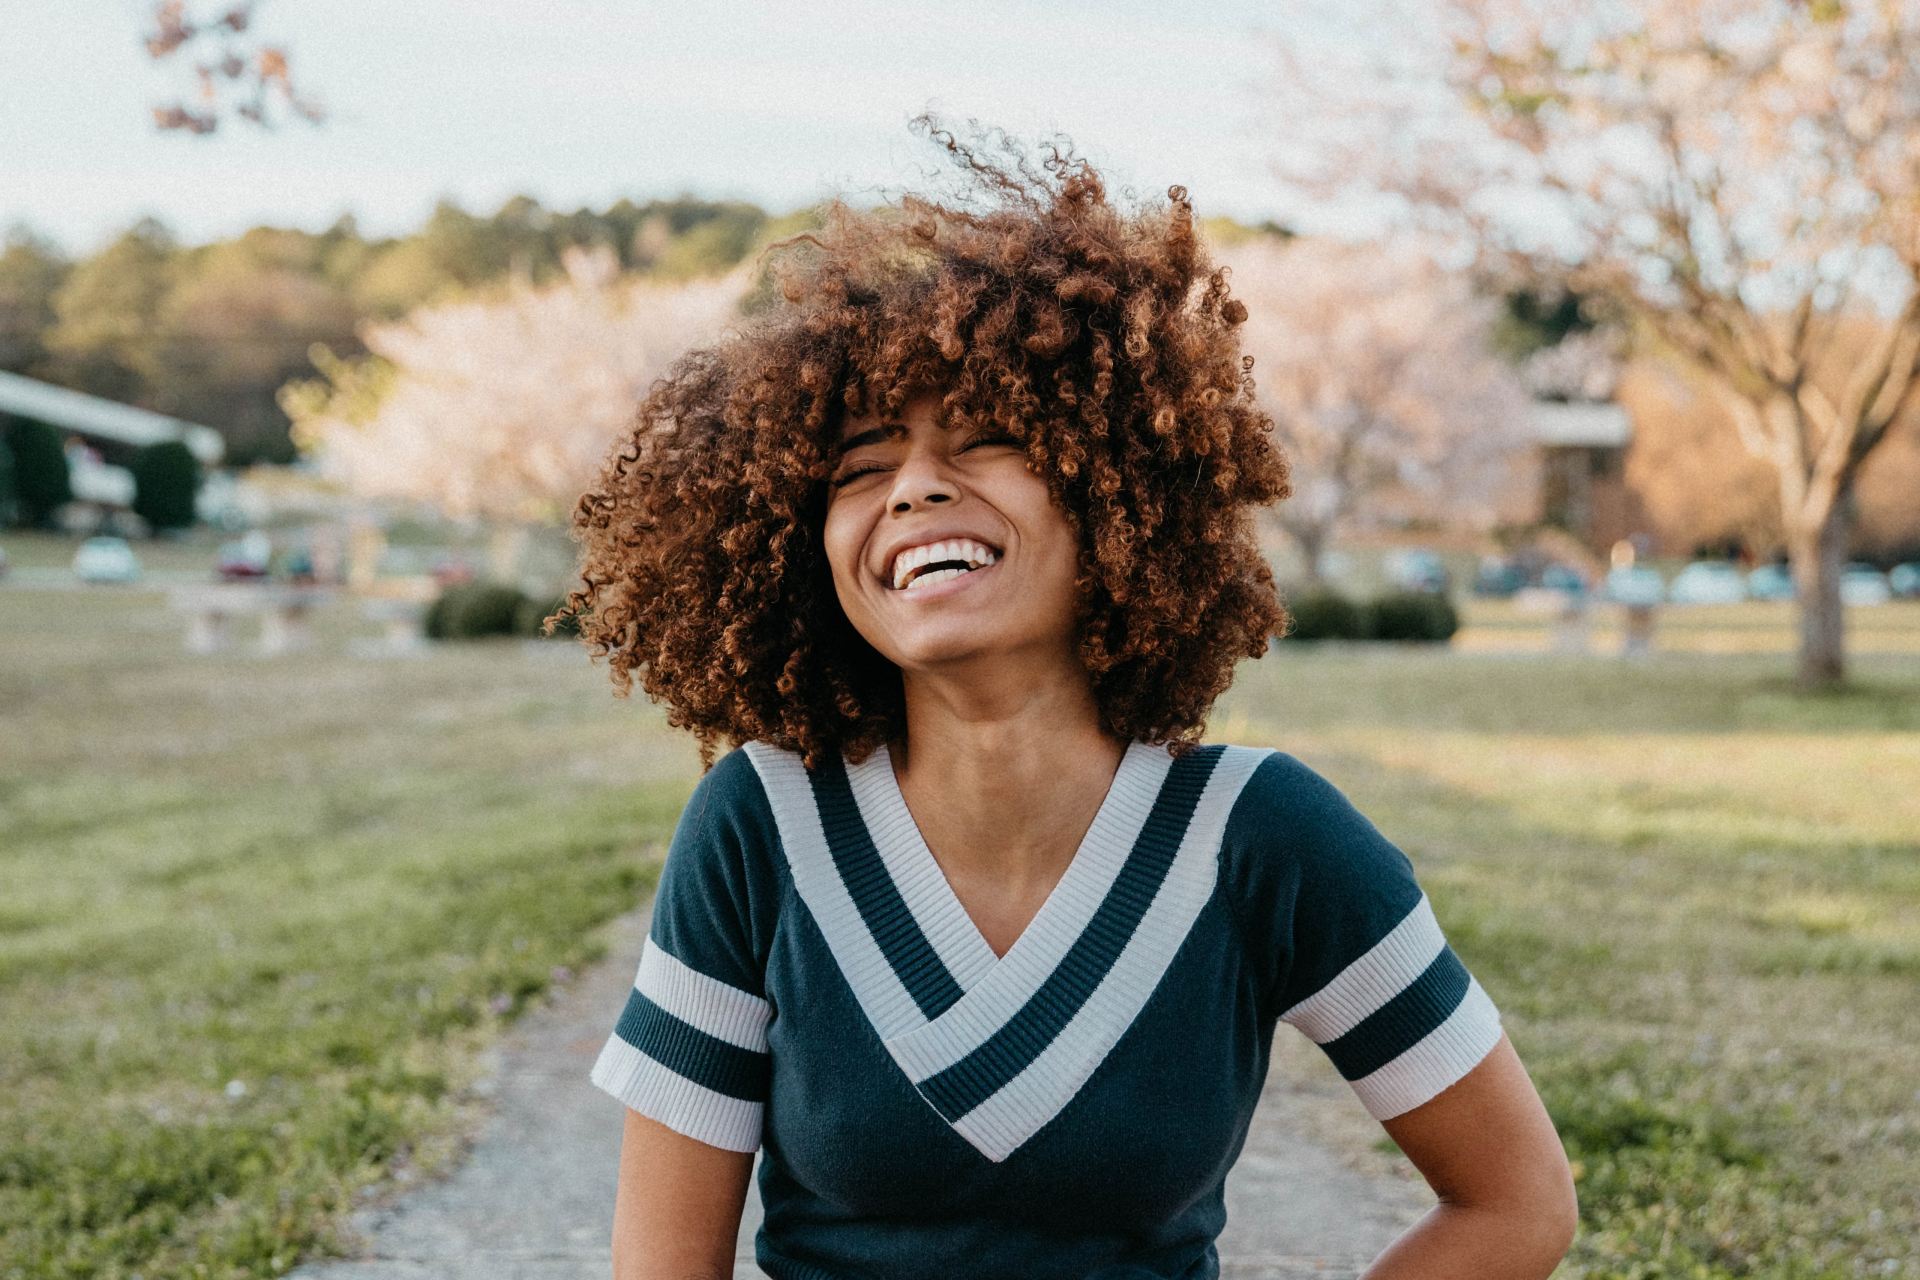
xmin=954 ymin=747 xmax=1271 ymax=1163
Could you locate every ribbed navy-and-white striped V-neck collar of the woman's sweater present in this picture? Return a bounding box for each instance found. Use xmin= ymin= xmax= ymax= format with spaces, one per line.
xmin=747 ymin=743 xmax=1267 ymax=1161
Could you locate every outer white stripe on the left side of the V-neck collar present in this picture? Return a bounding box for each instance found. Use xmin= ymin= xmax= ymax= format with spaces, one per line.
xmin=743 ymin=741 xmax=927 ymax=1040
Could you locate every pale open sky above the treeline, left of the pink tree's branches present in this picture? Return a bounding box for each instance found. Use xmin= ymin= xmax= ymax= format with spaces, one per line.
xmin=0 ymin=0 xmax=1374 ymax=251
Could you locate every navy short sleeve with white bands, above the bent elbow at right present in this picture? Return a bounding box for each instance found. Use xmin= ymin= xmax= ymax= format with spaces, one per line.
xmin=1225 ymin=752 xmax=1501 ymax=1121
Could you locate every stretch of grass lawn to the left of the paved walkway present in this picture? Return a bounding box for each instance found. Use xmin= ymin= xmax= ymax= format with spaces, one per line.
xmin=0 ymin=587 xmax=697 ymax=1280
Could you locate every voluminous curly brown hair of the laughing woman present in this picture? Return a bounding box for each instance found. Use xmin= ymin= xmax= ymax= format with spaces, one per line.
xmin=557 ymin=115 xmax=1290 ymax=770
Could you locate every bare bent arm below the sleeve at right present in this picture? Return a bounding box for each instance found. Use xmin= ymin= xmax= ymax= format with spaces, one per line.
xmin=1359 ymin=1032 xmax=1580 ymax=1280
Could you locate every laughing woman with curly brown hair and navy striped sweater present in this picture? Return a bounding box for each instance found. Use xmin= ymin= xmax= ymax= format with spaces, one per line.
xmin=570 ymin=117 xmax=1574 ymax=1280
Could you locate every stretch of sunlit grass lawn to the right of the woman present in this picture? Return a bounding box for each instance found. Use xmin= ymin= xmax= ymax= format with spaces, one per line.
xmin=1229 ymin=647 xmax=1920 ymax=1280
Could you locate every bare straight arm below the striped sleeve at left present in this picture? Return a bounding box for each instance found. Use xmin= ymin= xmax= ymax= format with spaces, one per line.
xmin=612 ymin=1107 xmax=753 ymax=1280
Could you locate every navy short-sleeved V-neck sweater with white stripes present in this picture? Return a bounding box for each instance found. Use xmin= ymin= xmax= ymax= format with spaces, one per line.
xmin=591 ymin=743 xmax=1501 ymax=1280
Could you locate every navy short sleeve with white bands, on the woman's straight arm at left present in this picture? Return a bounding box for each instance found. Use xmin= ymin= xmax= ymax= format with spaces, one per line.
xmin=591 ymin=750 xmax=774 ymax=1151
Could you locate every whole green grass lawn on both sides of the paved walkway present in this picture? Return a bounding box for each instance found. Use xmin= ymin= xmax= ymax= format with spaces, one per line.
xmin=0 ymin=564 xmax=1920 ymax=1280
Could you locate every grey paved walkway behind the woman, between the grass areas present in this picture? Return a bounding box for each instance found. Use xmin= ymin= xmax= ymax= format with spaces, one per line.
xmin=294 ymin=908 xmax=1432 ymax=1280
